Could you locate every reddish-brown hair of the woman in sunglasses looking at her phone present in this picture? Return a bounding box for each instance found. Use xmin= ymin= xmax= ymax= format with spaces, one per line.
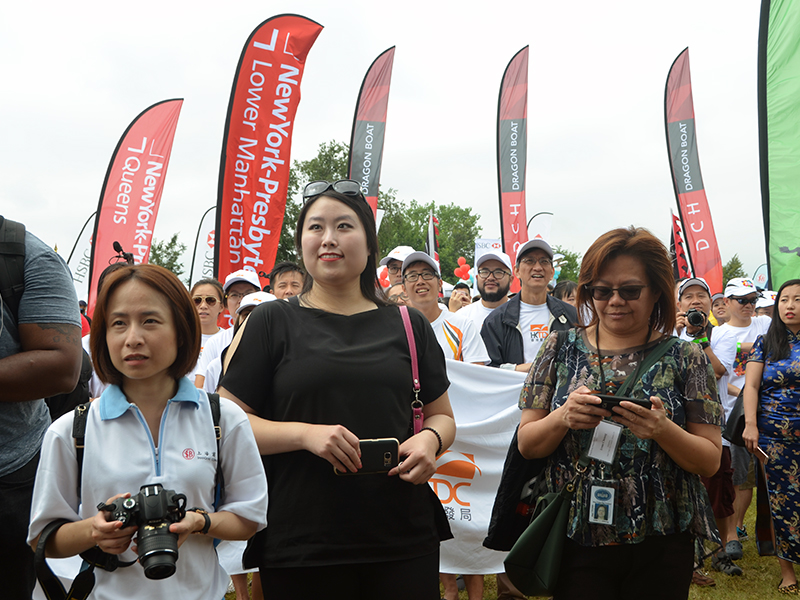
xmin=576 ymin=225 xmax=677 ymax=334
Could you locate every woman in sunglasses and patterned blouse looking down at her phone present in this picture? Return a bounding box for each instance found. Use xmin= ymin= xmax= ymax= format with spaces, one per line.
xmin=519 ymin=227 xmax=722 ymax=600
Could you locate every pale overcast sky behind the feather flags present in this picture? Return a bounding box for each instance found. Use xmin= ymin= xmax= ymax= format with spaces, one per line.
xmin=0 ymin=0 xmax=765 ymax=282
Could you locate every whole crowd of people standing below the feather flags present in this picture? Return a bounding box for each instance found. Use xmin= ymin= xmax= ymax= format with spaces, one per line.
xmin=0 ymin=189 xmax=800 ymax=600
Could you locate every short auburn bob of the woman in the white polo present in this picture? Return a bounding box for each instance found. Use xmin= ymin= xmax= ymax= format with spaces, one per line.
xmin=89 ymin=264 xmax=200 ymax=385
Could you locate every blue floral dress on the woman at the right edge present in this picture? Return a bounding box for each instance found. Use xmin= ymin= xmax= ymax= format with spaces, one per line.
xmin=750 ymin=330 xmax=800 ymax=563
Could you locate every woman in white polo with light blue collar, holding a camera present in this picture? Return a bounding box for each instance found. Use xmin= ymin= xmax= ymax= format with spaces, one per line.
xmin=29 ymin=265 xmax=267 ymax=600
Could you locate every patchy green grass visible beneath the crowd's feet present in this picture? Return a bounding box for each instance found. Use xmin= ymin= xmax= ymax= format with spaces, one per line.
xmin=225 ymin=499 xmax=787 ymax=600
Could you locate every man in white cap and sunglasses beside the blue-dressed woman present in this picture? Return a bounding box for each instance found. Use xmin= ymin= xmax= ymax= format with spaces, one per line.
xmin=711 ymin=277 xmax=772 ymax=572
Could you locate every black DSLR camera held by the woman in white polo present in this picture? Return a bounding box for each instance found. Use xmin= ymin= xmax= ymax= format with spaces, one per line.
xmin=97 ymin=483 xmax=186 ymax=579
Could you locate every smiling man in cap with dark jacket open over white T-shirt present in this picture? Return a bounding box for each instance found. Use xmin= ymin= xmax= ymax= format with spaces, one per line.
xmin=481 ymin=238 xmax=578 ymax=372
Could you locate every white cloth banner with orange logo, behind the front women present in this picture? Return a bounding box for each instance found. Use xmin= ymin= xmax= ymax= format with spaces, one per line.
xmin=429 ymin=360 xmax=525 ymax=575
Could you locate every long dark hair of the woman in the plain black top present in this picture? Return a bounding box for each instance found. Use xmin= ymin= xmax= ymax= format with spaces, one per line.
xmin=294 ymin=189 xmax=389 ymax=306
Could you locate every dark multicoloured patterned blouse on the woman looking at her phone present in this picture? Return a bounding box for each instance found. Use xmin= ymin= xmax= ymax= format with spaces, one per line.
xmin=519 ymin=329 xmax=723 ymax=546
